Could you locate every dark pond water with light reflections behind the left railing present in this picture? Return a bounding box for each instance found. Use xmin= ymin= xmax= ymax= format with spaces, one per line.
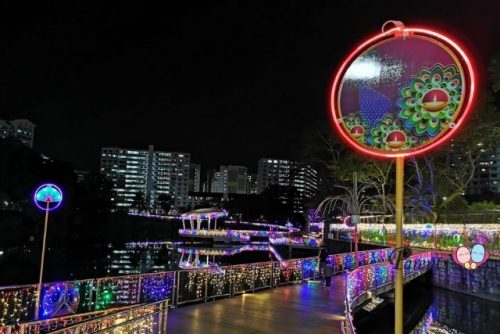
xmin=0 ymin=241 xmax=318 ymax=286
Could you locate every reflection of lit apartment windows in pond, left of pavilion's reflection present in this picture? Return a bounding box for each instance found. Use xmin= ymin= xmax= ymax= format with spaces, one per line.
xmin=106 ymin=242 xmax=179 ymax=275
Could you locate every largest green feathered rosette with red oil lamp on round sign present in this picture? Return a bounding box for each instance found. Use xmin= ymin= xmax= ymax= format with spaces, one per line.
xmin=398 ymin=64 xmax=462 ymax=137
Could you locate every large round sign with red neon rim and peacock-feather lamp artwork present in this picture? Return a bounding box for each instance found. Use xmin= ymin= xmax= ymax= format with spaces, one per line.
xmin=330 ymin=23 xmax=476 ymax=157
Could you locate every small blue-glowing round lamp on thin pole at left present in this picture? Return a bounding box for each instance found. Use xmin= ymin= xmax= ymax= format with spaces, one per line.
xmin=33 ymin=183 xmax=63 ymax=319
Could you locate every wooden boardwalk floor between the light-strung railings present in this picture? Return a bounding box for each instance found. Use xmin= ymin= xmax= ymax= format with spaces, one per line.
xmin=167 ymin=274 xmax=346 ymax=334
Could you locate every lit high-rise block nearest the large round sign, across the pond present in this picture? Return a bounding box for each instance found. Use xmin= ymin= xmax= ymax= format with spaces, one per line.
xmin=257 ymin=158 xmax=318 ymax=214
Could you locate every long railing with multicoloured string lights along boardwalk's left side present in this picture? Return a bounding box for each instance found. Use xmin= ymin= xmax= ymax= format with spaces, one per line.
xmin=0 ymin=249 xmax=391 ymax=330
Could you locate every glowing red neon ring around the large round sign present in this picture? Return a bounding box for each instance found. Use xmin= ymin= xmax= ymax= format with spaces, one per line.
xmin=330 ymin=27 xmax=477 ymax=158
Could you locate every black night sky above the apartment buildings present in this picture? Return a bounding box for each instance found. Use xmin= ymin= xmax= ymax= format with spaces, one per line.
xmin=0 ymin=0 xmax=500 ymax=170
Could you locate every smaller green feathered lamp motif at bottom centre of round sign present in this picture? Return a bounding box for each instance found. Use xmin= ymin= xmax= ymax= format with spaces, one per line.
xmin=368 ymin=114 xmax=419 ymax=151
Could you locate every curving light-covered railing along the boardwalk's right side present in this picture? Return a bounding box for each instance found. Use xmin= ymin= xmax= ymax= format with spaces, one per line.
xmin=345 ymin=252 xmax=432 ymax=333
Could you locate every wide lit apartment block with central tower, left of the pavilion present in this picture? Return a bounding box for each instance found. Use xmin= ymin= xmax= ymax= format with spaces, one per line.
xmin=101 ymin=145 xmax=190 ymax=211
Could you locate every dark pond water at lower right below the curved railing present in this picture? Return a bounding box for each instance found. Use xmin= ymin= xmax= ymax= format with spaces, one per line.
xmin=354 ymin=280 xmax=500 ymax=334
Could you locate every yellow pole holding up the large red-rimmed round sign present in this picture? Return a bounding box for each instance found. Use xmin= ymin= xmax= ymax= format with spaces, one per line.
xmin=394 ymin=156 xmax=405 ymax=334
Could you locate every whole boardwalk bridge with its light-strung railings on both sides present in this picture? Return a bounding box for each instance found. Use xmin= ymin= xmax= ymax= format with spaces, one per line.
xmin=0 ymin=249 xmax=431 ymax=334
